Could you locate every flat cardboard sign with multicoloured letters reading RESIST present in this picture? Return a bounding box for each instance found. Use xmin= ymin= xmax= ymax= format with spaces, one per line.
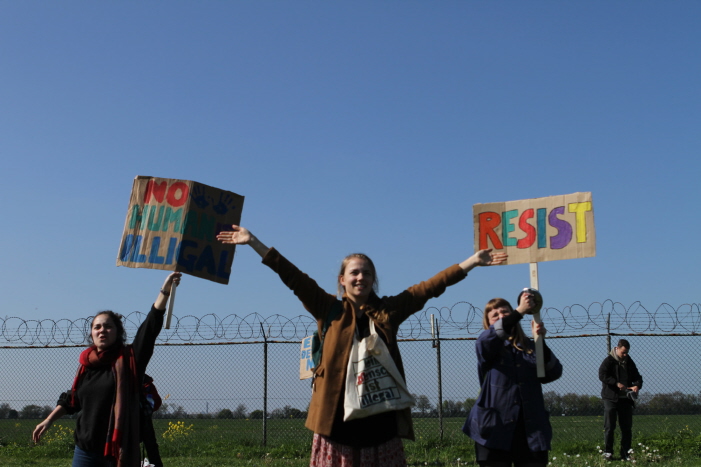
xmin=472 ymin=192 xmax=596 ymax=264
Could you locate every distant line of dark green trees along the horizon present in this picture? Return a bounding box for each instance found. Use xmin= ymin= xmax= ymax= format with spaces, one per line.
xmin=5 ymin=391 xmax=701 ymax=420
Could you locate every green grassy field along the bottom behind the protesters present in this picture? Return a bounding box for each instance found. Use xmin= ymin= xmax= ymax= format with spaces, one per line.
xmin=0 ymin=416 xmax=701 ymax=467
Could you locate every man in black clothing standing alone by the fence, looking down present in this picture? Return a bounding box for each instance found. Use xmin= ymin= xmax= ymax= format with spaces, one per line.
xmin=599 ymin=339 xmax=643 ymax=460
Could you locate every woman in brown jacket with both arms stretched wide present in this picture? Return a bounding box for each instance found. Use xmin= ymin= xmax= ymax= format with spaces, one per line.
xmin=217 ymin=225 xmax=506 ymax=467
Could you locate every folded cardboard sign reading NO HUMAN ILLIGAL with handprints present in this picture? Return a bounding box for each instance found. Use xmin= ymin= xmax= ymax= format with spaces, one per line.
xmin=117 ymin=176 xmax=244 ymax=284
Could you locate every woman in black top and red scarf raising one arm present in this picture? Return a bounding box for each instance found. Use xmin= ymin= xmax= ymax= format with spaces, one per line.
xmin=32 ymin=272 xmax=182 ymax=467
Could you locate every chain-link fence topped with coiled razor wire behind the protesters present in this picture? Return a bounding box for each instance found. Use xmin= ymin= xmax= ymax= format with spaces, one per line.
xmin=0 ymin=301 xmax=701 ymax=452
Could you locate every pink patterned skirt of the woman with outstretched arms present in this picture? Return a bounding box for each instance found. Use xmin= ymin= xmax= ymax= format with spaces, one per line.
xmin=309 ymin=433 xmax=406 ymax=467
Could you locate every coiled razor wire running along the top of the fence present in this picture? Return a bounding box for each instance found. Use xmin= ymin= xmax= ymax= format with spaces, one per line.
xmin=0 ymin=300 xmax=701 ymax=347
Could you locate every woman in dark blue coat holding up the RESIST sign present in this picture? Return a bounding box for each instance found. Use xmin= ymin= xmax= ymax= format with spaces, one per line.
xmin=463 ymin=289 xmax=562 ymax=467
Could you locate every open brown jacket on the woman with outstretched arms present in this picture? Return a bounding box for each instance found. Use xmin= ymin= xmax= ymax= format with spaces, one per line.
xmin=263 ymin=248 xmax=466 ymax=440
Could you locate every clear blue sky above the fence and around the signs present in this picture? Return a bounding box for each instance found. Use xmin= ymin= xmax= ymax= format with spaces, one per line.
xmin=0 ymin=1 xmax=701 ymax=330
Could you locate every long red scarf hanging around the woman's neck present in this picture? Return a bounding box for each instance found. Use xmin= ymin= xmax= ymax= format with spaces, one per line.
xmin=71 ymin=345 xmax=140 ymax=467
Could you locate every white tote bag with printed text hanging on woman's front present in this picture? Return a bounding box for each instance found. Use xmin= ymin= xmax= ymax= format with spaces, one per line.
xmin=343 ymin=320 xmax=415 ymax=421
